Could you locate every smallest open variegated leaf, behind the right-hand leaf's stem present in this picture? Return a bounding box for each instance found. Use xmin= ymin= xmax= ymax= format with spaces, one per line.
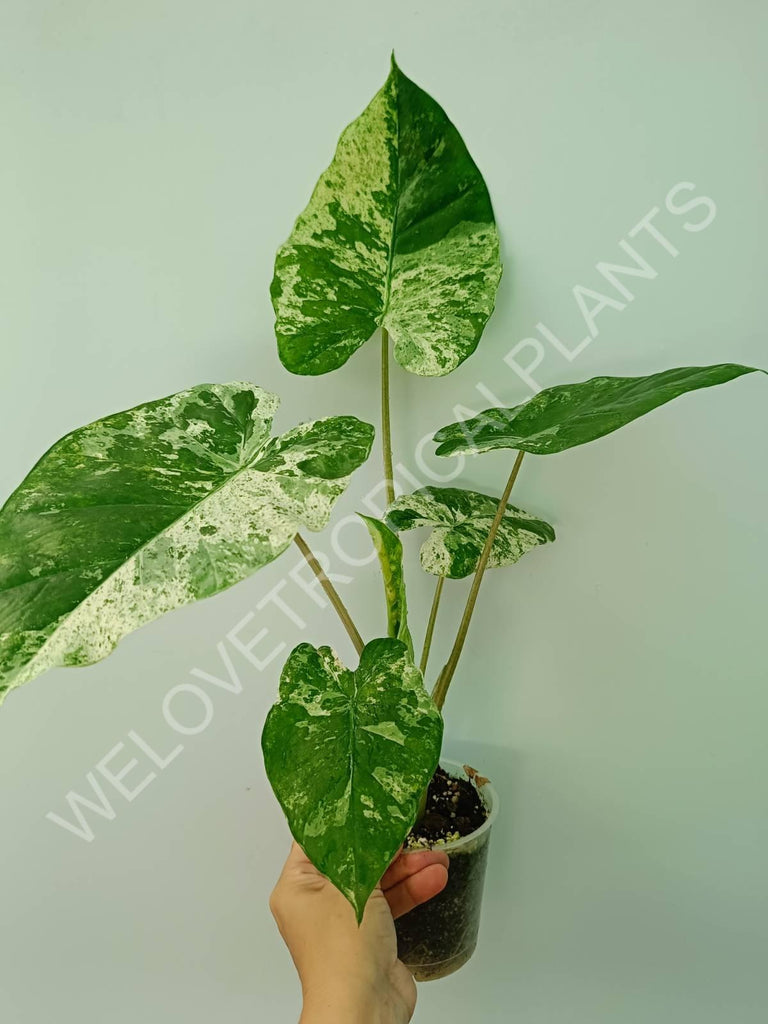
xmin=387 ymin=487 xmax=555 ymax=580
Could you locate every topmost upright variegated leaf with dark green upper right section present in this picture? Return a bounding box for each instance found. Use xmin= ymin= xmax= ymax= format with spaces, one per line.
xmin=271 ymin=58 xmax=502 ymax=377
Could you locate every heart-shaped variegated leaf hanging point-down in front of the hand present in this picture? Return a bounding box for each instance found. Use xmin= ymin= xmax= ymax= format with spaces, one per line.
xmin=261 ymin=638 xmax=442 ymax=921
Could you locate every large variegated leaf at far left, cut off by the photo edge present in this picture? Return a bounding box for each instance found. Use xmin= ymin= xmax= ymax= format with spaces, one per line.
xmin=0 ymin=383 xmax=373 ymax=699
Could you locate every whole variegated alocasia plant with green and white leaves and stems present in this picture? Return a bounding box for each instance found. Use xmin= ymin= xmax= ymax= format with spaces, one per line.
xmin=0 ymin=59 xmax=765 ymax=920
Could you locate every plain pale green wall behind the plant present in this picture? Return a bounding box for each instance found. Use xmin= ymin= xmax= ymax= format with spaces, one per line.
xmin=0 ymin=0 xmax=768 ymax=1024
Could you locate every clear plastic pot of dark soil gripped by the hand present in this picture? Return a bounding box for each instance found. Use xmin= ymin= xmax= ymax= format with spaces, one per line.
xmin=395 ymin=758 xmax=499 ymax=981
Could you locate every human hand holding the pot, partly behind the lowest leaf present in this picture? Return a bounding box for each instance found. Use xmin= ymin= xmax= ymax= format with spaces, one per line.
xmin=269 ymin=843 xmax=449 ymax=1024
